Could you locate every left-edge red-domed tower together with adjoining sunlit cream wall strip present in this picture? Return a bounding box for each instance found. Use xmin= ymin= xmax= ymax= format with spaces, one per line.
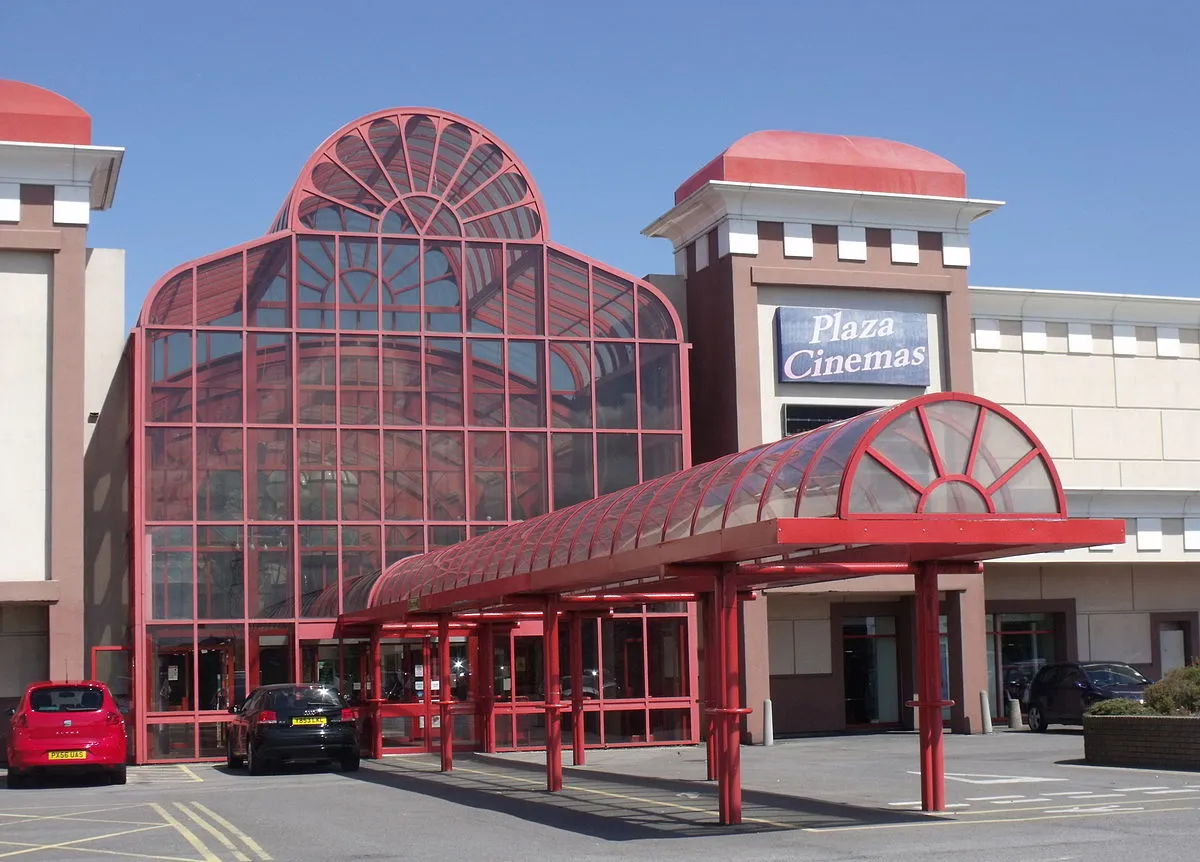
xmin=0 ymin=80 xmax=125 ymax=704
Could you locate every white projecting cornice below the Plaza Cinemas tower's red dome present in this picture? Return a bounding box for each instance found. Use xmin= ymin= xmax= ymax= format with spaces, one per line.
xmin=642 ymin=180 xmax=1004 ymax=250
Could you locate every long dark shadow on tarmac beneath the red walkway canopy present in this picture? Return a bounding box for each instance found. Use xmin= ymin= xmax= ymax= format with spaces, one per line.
xmin=347 ymin=754 xmax=928 ymax=842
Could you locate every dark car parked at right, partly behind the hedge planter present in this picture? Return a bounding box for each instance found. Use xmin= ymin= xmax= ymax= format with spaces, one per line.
xmin=1026 ymin=662 xmax=1150 ymax=731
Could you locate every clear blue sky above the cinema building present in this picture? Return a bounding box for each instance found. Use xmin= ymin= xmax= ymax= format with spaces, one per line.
xmin=0 ymin=0 xmax=1200 ymax=331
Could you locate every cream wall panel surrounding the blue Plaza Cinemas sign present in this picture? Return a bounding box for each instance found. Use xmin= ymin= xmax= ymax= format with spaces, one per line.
xmin=758 ymin=287 xmax=944 ymax=443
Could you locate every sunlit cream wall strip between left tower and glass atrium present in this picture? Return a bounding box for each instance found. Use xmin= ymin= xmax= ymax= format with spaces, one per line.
xmin=83 ymin=249 xmax=126 ymax=450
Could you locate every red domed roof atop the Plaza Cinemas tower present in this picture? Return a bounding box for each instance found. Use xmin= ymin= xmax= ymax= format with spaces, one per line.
xmin=676 ymin=131 xmax=967 ymax=204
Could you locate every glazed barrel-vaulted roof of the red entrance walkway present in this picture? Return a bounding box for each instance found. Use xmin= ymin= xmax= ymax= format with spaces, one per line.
xmin=344 ymin=393 xmax=1066 ymax=612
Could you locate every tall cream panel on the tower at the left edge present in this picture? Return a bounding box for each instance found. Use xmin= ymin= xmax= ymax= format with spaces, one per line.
xmin=0 ymin=251 xmax=53 ymax=588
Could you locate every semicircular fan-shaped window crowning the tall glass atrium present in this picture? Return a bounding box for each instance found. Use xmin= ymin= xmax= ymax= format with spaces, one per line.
xmin=290 ymin=112 xmax=545 ymax=240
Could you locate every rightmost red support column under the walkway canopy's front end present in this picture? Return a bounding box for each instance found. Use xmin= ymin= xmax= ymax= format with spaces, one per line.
xmin=914 ymin=563 xmax=953 ymax=812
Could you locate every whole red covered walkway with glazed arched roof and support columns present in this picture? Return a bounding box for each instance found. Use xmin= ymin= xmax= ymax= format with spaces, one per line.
xmin=343 ymin=393 xmax=1124 ymax=824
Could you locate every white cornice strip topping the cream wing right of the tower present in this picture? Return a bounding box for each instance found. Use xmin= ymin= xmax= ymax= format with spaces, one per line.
xmin=970 ymin=287 xmax=1200 ymax=327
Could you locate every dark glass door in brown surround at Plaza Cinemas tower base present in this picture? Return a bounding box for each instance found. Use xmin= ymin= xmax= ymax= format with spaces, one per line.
xmin=841 ymin=616 xmax=900 ymax=728
